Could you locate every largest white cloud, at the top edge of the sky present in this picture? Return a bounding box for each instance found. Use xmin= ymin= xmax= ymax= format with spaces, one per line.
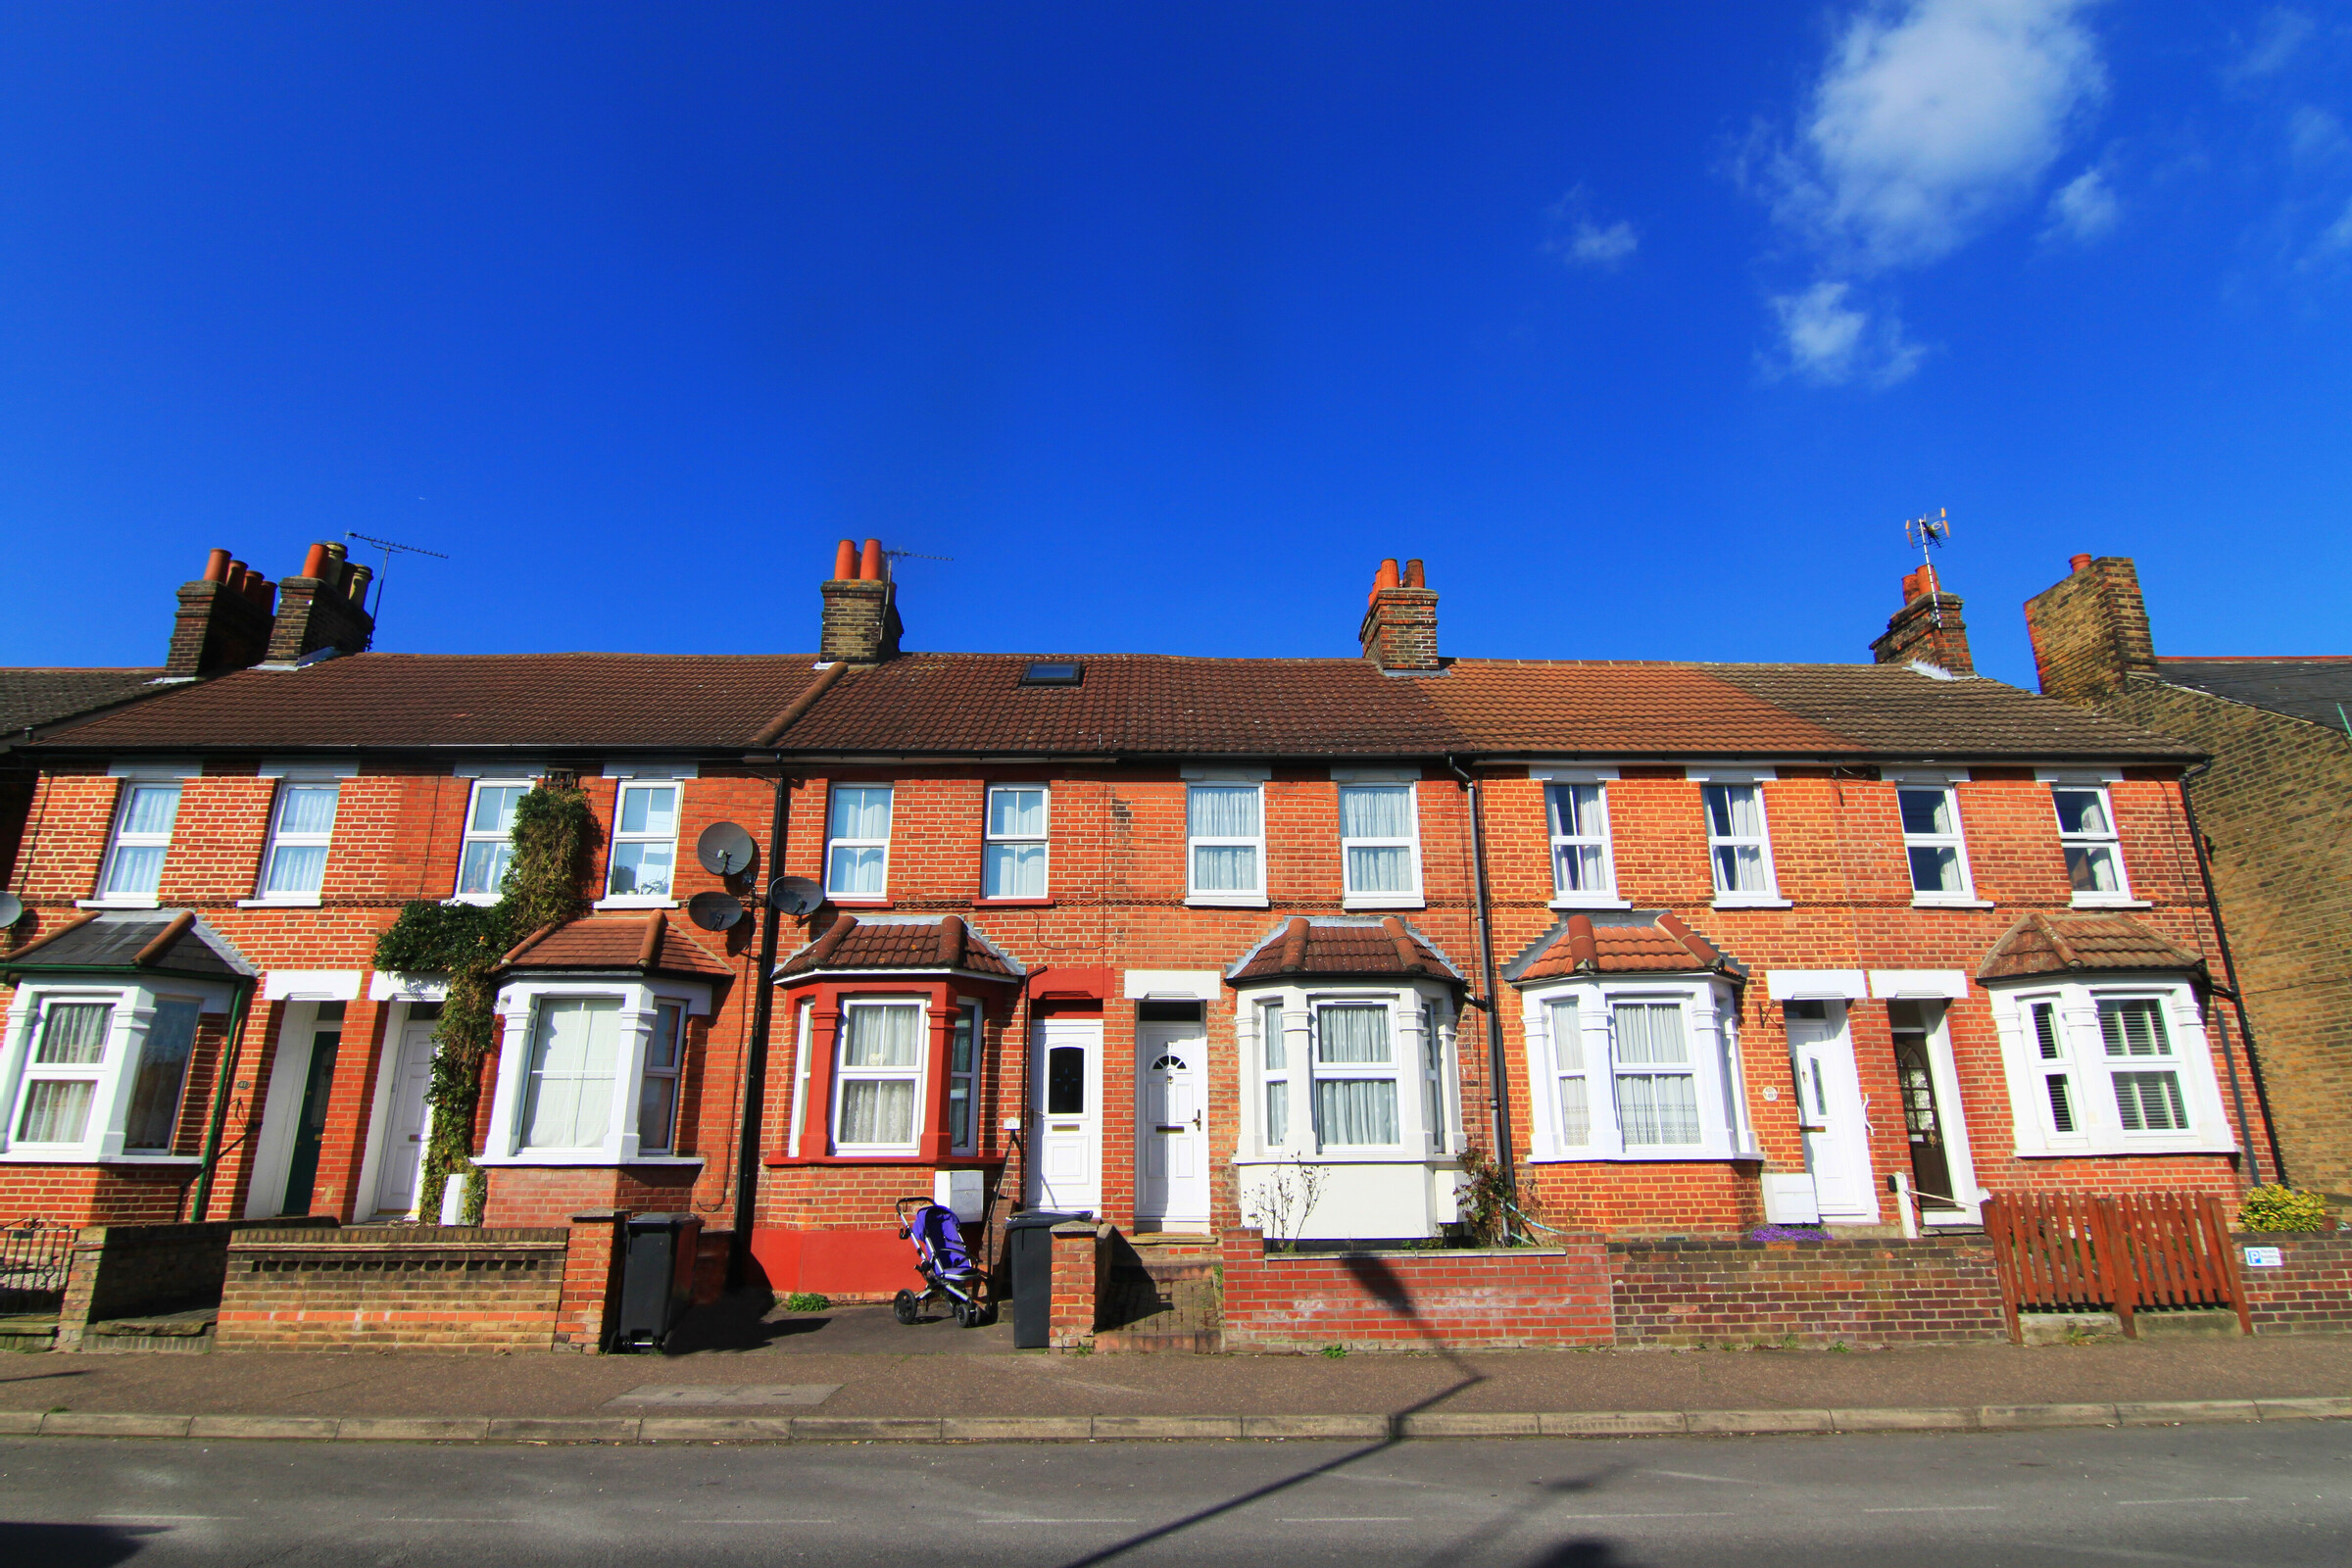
xmin=1769 ymin=0 xmax=2105 ymax=272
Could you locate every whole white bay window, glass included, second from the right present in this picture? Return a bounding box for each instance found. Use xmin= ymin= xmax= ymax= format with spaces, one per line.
xmin=1524 ymin=980 xmax=1754 ymax=1159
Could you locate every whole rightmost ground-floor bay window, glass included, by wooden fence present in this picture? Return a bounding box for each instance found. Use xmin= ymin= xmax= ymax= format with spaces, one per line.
xmin=1987 ymin=980 xmax=2236 ymax=1156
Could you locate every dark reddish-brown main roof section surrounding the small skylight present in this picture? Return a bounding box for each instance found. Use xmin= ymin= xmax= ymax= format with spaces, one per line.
xmin=776 ymin=654 xmax=1460 ymax=757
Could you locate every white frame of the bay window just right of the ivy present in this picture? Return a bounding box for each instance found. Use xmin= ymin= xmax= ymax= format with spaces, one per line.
xmin=467 ymin=976 xmax=710 ymax=1165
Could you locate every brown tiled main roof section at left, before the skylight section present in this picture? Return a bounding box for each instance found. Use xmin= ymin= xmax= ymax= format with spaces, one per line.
xmin=36 ymin=654 xmax=816 ymax=750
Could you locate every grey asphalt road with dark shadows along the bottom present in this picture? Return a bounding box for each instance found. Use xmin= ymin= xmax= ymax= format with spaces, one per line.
xmin=0 ymin=1422 xmax=2352 ymax=1568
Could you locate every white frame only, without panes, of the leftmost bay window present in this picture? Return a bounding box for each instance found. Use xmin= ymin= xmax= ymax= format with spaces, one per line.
xmin=0 ymin=976 xmax=228 ymax=1166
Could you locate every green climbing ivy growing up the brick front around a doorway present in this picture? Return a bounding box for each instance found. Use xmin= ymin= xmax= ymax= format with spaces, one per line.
xmin=376 ymin=776 xmax=598 ymax=1225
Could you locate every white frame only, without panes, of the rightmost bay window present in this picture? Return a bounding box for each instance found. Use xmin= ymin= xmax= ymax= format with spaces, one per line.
xmin=1985 ymin=976 xmax=2236 ymax=1159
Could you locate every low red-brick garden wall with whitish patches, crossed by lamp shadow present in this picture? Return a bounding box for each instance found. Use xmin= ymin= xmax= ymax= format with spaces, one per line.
xmin=1221 ymin=1230 xmax=1611 ymax=1349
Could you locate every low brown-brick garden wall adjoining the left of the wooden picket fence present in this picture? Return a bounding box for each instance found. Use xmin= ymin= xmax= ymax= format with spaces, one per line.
xmin=1609 ymin=1237 xmax=2009 ymax=1345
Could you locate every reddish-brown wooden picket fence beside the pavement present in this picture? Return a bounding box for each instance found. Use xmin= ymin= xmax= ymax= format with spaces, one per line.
xmin=1985 ymin=1192 xmax=2253 ymax=1343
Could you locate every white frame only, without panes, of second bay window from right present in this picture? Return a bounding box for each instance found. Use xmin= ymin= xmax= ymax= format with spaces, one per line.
xmin=1519 ymin=976 xmax=1759 ymax=1163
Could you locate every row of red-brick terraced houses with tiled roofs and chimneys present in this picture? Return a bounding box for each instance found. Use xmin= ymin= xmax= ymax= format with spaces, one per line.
xmin=0 ymin=543 xmax=2265 ymax=1296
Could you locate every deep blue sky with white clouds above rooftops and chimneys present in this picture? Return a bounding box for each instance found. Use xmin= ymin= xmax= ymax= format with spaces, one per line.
xmin=0 ymin=0 xmax=2352 ymax=684
